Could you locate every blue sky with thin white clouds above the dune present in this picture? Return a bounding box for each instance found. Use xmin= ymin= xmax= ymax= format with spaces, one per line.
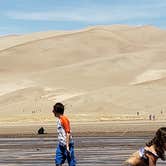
xmin=0 ymin=0 xmax=166 ymax=35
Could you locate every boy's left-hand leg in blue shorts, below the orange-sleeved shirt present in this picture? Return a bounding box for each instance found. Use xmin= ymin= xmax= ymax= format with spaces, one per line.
xmin=55 ymin=144 xmax=66 ymax=166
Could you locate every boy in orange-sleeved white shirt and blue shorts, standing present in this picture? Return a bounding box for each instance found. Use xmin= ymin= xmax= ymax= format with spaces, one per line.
xmin=52 ymin=103 xmax=76 ymax=166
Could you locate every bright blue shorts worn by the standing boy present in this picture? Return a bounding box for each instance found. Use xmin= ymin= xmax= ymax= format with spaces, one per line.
xmin=55 ymin=143 xmax=76 ymax=166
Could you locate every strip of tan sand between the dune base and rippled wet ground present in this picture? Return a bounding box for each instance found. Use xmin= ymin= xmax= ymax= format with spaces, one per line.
xmin=0 ymin=120 xmax=166 ymax=137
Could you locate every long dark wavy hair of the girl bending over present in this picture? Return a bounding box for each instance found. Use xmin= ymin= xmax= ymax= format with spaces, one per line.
xmin=146 ymin=127 xmax=166 ymax=160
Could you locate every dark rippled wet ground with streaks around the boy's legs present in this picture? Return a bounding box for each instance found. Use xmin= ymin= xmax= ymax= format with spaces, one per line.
xmin=0 ymin=132 xmax=165 ymax=166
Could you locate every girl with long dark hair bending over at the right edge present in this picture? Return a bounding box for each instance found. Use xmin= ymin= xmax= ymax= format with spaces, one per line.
xmin=124 ymin=127 xmax=166 ymax=166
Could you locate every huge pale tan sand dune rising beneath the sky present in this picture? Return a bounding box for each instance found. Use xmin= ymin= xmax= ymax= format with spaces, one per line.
xmin=0 ymin=25 xmax=166 ymax=130
